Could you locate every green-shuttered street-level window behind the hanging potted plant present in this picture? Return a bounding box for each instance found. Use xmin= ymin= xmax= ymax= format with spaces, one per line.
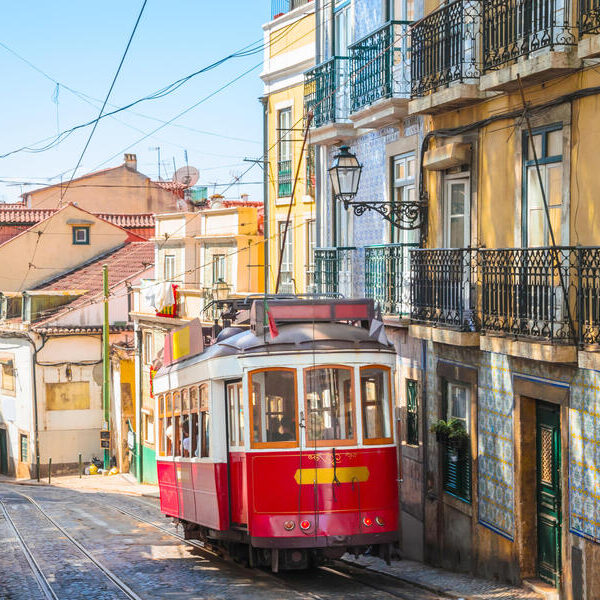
xmin=442 ymin=381 xmax=471 ymax=502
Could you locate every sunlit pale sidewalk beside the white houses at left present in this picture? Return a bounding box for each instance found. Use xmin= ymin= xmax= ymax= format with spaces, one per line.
xmin=0 ymin=473 xmax=159 ymax=498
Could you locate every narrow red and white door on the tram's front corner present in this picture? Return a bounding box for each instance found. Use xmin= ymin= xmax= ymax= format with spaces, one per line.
xmin=226 ymin=380 xmax=248 ymax=529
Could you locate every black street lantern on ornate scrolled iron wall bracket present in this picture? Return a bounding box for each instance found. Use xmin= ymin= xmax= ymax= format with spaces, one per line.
xmin=328 ymin=146 xmax=427 ymax=229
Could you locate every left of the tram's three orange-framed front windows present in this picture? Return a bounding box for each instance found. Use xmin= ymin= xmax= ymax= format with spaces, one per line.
xmin=250 ymin=369 xmax=298 ymax=448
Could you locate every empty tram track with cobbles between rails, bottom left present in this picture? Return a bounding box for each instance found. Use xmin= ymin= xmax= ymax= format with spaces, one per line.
xmin=0 ymin=492 xmax=143 ymax=600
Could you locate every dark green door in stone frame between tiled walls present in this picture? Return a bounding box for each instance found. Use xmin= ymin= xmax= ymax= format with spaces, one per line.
xmin=536 ymin=402 xmax=561 ymax=587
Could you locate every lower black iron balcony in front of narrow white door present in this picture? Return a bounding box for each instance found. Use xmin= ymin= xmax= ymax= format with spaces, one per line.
xmin=410 ymin=248 xmax=478 ymax=331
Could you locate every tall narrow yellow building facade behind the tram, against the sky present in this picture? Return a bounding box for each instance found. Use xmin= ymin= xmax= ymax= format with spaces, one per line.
xmin=261 ymin=2 xmax=316 ymax=294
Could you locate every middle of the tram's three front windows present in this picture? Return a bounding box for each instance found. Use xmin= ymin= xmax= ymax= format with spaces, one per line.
xmin=304 ymin=367 xmax=356 ymax=445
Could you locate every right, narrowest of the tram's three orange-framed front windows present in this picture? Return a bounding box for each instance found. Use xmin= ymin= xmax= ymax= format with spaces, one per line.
xmin=360 ymin=367 xmax=392 ymax=444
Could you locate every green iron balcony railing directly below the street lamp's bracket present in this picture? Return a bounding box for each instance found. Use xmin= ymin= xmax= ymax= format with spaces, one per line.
xmin=365 ymin=244 xmax=418 ymax=317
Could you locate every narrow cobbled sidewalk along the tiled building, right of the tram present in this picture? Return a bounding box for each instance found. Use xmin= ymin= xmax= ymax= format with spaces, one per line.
xmin=342 ymin=554 xmax=542 ymax=600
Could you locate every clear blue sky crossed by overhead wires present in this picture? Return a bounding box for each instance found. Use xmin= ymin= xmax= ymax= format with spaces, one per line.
xmin=0 ymin=0 xmax=271 ymax=202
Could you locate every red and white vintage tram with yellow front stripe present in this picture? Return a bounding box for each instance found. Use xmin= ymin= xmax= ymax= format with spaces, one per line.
xmin=153 ymin=300 xmax=398 ymax=570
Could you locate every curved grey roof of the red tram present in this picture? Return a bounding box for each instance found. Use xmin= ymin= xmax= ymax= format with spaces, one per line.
xmin=156 ymin=323 xmax=393 ymax=377
